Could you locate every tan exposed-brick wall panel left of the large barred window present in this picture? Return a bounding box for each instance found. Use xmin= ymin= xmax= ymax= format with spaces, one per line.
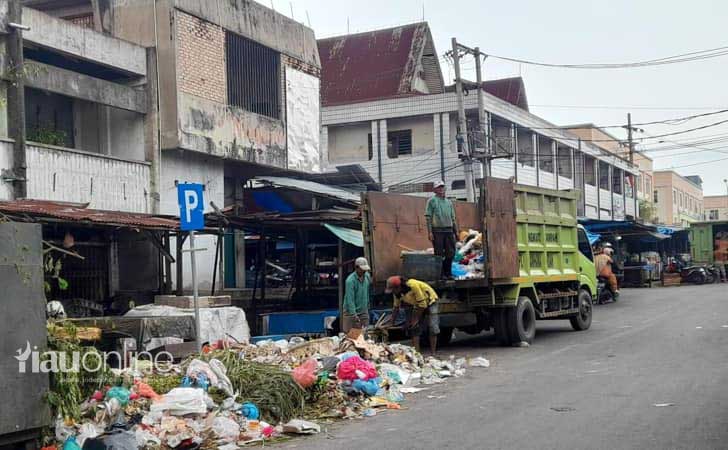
xmin=175 ymin=11 xmax=227 ymax=103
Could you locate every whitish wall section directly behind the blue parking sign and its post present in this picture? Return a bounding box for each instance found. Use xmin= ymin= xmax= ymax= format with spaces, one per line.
xmin=160 ymin=150 xmax=225 ymax=291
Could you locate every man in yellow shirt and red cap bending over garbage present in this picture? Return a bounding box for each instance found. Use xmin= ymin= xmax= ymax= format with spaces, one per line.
xmin=384 ymin=275 xmax=440 ymax=355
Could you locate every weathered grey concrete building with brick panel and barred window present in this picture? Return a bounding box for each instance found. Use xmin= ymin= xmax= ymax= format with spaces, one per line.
xmin=0 ymin=0 xmax=321 ymax=290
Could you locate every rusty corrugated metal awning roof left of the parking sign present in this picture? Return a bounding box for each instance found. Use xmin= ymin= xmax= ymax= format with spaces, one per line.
xmin=0 ymin=200 xmax=179 ymax=230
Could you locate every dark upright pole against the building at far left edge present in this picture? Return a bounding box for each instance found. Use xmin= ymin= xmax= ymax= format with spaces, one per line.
xmin=7 ymin=0 xmax=28 ymax=199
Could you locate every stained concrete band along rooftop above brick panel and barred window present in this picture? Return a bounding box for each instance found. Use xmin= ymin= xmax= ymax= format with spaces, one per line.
xmin=174 ymin=0 xmax=321 ymax=67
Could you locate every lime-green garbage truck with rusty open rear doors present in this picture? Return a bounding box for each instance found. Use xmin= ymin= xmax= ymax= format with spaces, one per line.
xmin=362 ymin=178 xmax=597 ymax=345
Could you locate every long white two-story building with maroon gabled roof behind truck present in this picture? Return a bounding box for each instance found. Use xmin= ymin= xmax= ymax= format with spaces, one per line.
xmin=318 ymin=22 xmax=638 ymax=219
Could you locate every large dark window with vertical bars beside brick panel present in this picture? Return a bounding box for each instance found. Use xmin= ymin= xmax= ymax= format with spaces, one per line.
xmin=225 ymin=32 xmax=281 ymax=119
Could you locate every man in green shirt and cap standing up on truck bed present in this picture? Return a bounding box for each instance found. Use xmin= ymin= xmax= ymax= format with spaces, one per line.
xmin=425 ymin=181 xmax=458 ymax=278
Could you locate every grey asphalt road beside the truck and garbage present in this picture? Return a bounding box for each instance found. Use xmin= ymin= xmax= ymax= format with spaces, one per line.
xmin=283 ymin=284 xmax=728 ymax=450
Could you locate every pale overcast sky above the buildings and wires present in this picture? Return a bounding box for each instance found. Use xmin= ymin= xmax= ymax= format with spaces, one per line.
xmin=282 ymin=0 xmax=728 ymax=195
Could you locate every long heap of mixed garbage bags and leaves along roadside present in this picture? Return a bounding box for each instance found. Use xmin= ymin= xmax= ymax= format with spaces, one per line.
xmin=45 ymin=335 xmax=489 ymax=450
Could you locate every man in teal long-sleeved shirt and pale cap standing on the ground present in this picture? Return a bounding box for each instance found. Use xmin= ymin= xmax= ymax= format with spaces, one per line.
xmin=341 ymin=257 xmax=372 ymax=333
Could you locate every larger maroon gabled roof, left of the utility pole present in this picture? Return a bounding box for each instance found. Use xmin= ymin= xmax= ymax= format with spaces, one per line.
xmin=317 ymin=22 xmax=442 ymax=106
